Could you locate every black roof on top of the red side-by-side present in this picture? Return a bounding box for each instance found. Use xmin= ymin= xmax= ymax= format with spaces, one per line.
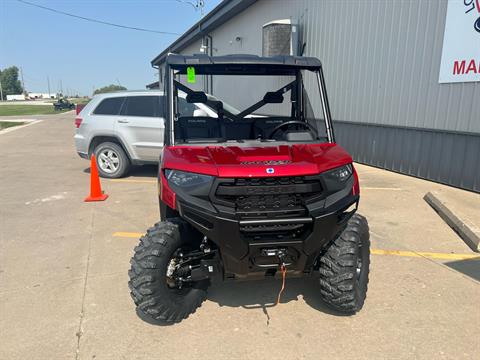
xmin=166 ymin=54 xmax=322 ymax=75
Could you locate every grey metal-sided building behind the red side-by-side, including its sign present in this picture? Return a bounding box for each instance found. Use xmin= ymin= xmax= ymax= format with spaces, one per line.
xmin=152 ymin=0 xmax=480 ymax=192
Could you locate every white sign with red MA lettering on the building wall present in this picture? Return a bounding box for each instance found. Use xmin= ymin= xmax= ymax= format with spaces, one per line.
xmin=438 ymin=0 xmax=480 ymax=83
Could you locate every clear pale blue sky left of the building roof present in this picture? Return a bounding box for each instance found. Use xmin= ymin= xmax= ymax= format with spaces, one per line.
xmin=0 ymin=0 xmax=221 ymax=95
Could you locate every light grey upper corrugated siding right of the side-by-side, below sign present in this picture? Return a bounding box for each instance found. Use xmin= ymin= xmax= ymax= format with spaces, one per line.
xmin=304 ymin=0 xmax=480 ymax=133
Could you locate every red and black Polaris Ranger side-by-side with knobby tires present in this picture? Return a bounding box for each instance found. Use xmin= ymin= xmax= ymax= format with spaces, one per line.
xmin=129 ymin=54 xmax=370 ymax=323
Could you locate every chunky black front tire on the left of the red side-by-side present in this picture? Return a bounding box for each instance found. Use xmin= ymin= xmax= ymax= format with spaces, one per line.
xmin=128 ymin=221 xmax=208 ymax=323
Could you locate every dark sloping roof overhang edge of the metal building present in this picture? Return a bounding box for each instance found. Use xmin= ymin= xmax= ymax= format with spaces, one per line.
xmin=151 ymin=0 xmax=257 ymax=66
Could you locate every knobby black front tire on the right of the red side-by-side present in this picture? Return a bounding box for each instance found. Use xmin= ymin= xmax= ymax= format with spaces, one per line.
xmin=319 ymin=214 xmax=370 ymax=314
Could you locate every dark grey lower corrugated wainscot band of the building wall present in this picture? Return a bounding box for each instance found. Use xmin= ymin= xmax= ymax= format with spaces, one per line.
xmin=334 ymin=121 xmax=480 ymax=192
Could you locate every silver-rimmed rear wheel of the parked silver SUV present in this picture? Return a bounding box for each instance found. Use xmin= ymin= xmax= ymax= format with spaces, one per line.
xmin=94 ymin=142 xmax=130 ymax=179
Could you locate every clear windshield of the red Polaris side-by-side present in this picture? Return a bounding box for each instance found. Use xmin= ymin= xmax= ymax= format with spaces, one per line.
xmin=169 ymin=71 xmax=328 ymax=143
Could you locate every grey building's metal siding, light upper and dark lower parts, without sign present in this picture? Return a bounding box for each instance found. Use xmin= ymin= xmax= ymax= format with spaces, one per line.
xmin=167 ymin=0 xmax=480 ymax=191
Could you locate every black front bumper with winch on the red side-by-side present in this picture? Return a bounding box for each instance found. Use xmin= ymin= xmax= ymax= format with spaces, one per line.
xmin=172 ymin=176 xmax=359 ymax=279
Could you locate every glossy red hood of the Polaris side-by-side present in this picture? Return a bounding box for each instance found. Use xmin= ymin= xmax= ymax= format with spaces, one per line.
xmin=162 ymin=143 xmax=352 ymax=178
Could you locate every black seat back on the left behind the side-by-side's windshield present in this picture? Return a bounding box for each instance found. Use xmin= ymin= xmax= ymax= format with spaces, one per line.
xmin=175 ymin=116 xmax=224 ymax=141
